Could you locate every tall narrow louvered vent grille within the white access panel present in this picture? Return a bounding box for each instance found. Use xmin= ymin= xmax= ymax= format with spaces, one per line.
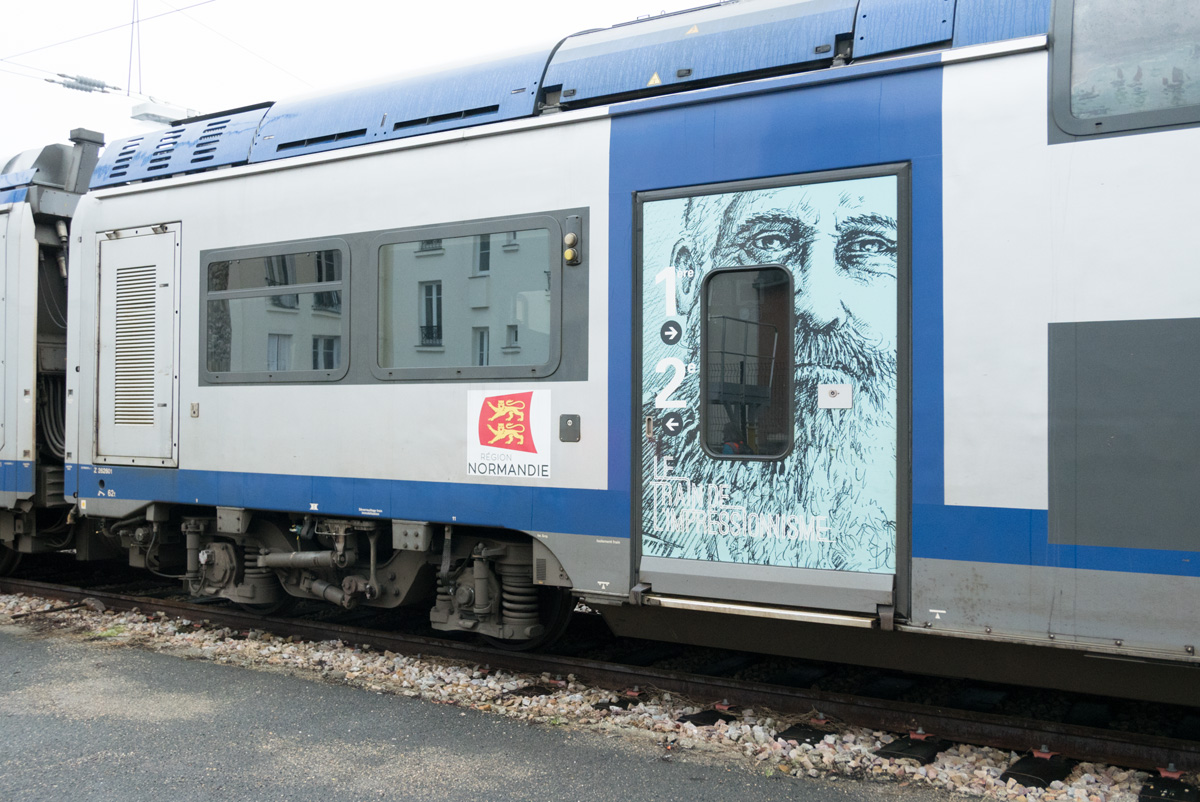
xmin=113 ymin=264 xmax=156 ymax=426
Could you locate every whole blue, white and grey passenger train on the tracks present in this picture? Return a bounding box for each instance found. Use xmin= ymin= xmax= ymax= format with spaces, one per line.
xmin=0 ymin=0 xmax=1200 ymax=700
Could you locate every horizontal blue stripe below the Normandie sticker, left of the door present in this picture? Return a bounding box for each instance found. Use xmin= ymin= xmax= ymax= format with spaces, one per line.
xmin=68 ymin=465 xmax=629 ymax=538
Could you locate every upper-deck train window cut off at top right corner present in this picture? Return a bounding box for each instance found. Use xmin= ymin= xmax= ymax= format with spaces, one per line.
xmin=1054 ymin=0 xmax=1200 ymax=134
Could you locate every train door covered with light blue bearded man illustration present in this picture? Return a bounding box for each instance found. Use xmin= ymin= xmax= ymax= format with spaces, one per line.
xmin=635 ymin=166 xmax=907 ymax=615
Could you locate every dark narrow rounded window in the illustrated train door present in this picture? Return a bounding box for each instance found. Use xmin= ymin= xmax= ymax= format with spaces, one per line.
xmin=701 ymin=267 xmax=796 ymax=459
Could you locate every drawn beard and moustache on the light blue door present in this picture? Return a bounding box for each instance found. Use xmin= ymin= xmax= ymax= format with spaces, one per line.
xmin=643 ymin=324 xmax=896 ymax=571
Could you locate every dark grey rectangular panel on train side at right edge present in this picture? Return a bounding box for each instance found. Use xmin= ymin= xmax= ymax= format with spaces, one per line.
xmin=1049 ymin=318 xmax=1200 ymax=551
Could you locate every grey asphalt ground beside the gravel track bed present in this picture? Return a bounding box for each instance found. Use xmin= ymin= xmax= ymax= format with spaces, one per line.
xmin=0 ymin=626 xmax=948 ymax=802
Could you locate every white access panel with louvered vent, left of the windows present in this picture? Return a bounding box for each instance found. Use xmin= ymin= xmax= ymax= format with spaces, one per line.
xmin=96 ymin=223 xmax=180 ymax=467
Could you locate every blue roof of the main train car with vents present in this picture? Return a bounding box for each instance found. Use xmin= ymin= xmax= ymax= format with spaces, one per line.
xmin=91 ymin=0 xmax=1050 ymax=188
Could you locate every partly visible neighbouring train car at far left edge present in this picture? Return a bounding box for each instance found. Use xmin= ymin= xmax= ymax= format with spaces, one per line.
xmin=0 ymin=128 xmax=104 ymax=575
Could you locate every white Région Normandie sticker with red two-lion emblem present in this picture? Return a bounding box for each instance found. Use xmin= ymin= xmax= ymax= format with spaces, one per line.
xmin=467 ymin=390 xmax=551 ymax=479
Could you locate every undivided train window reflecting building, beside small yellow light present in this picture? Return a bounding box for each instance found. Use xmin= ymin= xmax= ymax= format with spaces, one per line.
xmin=374 ymin=217 xmax=562 ymax=379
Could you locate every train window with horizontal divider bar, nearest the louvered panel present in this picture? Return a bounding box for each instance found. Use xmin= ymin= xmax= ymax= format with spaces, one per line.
xmin=203 ymin=241 xmax=349 ymax=382
